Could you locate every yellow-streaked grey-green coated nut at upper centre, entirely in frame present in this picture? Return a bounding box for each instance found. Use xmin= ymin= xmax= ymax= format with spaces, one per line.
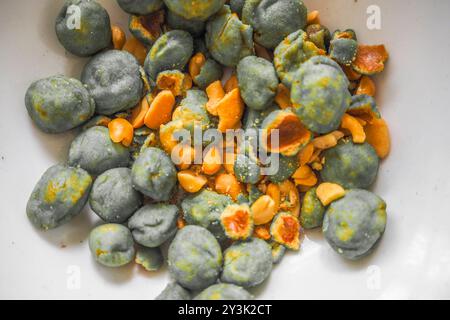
xmin=205 ymin=6 xmax=254 ymax=67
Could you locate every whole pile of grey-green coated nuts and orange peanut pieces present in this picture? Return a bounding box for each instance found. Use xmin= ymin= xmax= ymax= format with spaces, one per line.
xmin=25 ymin=0 xmax=390 ymax=300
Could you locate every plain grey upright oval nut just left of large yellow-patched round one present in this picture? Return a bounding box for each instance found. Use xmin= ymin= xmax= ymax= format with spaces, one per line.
xmin=237 ymin=56 xmax=279 ymax=110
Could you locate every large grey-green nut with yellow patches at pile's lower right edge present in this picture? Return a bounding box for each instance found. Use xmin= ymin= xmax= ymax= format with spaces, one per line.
xmin=323 ymin=189 xmax=387 ymax=260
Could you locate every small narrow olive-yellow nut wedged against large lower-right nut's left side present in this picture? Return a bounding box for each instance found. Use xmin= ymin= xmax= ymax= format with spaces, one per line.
xmin=300 ymin=188 xmax=325 ymax=229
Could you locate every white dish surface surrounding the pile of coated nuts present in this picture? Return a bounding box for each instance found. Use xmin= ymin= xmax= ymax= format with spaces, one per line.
xmin=0 ymin=0 xmax=450 ymax=299
